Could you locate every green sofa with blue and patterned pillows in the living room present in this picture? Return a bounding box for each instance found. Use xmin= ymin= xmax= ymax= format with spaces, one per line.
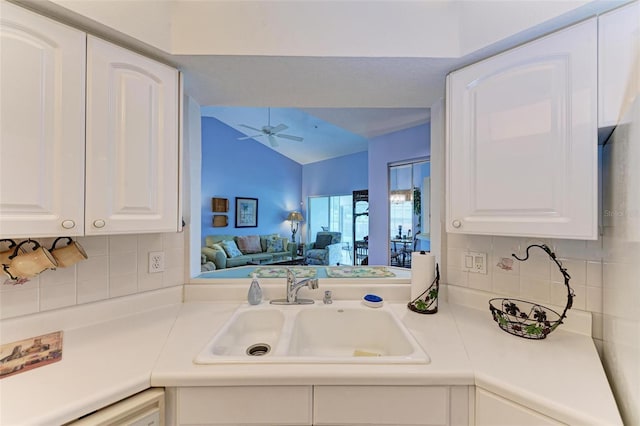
xmin=201 ymin=234 xmax=296 ymax=270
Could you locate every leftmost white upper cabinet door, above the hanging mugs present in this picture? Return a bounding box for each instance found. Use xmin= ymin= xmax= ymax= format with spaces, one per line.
xmin=0 ymin=1 xmax=86 ymax=237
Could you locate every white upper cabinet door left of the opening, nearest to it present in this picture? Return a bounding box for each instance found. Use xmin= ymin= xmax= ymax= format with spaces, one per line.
xmin=85 ymin=36 xmax=179 ymax=235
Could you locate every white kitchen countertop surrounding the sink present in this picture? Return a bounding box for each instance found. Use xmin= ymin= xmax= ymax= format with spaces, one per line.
xmin=0 ymin=284 xmax=622 ymax=426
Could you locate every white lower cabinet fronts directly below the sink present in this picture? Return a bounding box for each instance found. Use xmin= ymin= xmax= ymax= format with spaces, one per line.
xmin=168 ymin=386 xmax=473 ymax=426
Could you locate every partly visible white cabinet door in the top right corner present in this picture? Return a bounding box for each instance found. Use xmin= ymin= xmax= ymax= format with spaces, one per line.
xmin=598 ymin=1 xmax=640 ymax=127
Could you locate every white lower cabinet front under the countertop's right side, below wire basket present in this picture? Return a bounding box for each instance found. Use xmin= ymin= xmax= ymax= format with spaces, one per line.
xmin=476 ymin=388 xmax=564 ymax=426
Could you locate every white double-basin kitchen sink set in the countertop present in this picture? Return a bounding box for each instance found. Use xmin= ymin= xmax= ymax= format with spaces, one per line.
xmin=194 ymin=301 xmax=430 ymax=364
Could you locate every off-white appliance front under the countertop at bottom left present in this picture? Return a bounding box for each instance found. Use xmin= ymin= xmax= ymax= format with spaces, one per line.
xmin=67 ymin=388 xmax=165 ymax=426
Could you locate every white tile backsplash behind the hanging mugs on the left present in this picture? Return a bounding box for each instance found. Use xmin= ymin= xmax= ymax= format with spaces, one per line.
xmin=0 ymin=233 xmax=185 ymax=319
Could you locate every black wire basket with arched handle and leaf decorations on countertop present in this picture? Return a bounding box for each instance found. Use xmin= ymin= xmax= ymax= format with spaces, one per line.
xmin=489 ymin=244 xmax=575 ymax=339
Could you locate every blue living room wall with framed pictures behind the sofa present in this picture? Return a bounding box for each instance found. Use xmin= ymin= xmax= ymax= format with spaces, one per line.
xmin=202 ymin=117 xmax=302 ymax=245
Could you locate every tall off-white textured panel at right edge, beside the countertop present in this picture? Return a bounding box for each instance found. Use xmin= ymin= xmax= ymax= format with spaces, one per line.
xmin=602 ymin=97 xmax=640 ymax=425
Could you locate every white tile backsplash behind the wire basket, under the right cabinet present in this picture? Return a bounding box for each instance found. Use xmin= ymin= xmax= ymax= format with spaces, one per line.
xmin=445 ymin=234 xmax=603 ymax=332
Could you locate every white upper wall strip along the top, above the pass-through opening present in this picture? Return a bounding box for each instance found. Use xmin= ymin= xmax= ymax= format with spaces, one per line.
xmin=26 ymin=0 xmax=594 ymax=58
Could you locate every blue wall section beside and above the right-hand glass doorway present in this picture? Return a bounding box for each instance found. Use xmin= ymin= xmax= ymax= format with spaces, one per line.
xmin=368 ymin=123 xmax=431 ymax=265
